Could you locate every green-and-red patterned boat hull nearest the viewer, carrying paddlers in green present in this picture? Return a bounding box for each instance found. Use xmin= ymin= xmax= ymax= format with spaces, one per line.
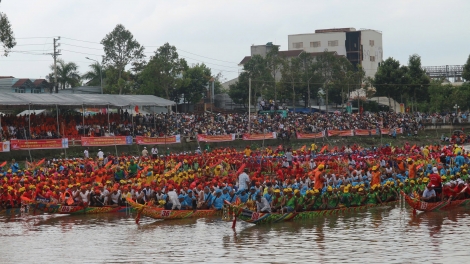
xmin=227 ymin=201 xmax=397 ymax=225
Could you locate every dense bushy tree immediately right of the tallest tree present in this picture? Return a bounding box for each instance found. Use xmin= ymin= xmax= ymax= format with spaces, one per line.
xmin=140 ymin=43 xmax=188 ymax=99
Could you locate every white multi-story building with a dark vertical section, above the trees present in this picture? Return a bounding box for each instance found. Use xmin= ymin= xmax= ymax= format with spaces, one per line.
xmin=288 ymin=28 xmax=383 ymax=77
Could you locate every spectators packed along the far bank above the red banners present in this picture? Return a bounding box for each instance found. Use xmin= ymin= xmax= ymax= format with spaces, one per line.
xmin=0 ymin=111 xmax=470 ymax=140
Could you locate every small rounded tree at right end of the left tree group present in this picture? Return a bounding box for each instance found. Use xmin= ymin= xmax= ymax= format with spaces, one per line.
xmin=178 ymin=63 xmax=211 ymax=104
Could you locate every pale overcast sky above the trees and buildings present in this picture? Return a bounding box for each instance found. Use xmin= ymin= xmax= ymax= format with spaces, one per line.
xmin=0 ymin=0 xmax=470 ymax=82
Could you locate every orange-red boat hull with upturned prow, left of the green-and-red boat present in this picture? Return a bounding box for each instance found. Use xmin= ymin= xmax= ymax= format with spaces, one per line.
xmin=127 ymin=198 xmax=222 ymax=224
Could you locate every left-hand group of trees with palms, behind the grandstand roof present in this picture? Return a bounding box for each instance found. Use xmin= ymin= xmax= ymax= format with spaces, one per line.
xmin=47 ymin=24 xmax=223 ymax=103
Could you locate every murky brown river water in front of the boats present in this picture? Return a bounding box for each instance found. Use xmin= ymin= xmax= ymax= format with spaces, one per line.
xmin=0 ymin=200 xmax=470 ymax=263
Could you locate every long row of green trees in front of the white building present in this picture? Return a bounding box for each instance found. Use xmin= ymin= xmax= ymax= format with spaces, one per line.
xmin=229 ymin=43 xmax=470 ymax=112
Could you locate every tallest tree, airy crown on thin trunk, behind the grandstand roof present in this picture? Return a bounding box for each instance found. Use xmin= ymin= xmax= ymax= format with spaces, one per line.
xmin=101 ymin=24 xmax=145 ymax=94
